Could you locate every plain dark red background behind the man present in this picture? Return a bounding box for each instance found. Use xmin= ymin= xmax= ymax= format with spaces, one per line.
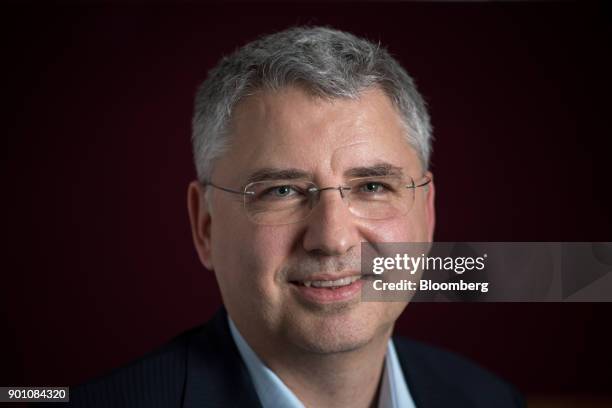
xmin=0 ymin=2 xmax=612 ymax=395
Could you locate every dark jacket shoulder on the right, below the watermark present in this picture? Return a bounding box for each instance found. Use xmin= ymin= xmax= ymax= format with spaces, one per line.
xmin=393 ymin=337 xmax=525 ymax=407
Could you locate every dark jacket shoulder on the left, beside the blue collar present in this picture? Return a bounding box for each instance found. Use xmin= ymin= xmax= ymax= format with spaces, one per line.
xmin=45 ymin=309 xmax=258 ymax=408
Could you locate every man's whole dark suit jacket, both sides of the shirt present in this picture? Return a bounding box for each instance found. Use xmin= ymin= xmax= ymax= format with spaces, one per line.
xmin=46 ymin=309 xmax=525 ymax=408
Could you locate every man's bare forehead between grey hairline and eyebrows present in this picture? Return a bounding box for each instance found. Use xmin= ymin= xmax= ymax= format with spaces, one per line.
xmin=214 ymin=87 xmax=420 ymax=180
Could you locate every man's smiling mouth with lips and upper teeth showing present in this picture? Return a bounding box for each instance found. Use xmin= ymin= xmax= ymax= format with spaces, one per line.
xmin=290 ymin=274 xmax=370 ymax=303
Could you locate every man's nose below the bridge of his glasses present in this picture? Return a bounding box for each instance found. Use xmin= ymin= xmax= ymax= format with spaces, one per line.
xmin=303 ymin=188 xmax=360 ymax=255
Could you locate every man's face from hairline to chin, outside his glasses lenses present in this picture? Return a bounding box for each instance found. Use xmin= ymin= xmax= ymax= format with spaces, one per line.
xmin=192 ymin=87 xmax=434 ymax=353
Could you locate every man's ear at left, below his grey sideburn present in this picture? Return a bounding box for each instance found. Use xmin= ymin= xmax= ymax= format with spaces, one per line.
xmin=187 ymin=181 xmax=214 ymax=271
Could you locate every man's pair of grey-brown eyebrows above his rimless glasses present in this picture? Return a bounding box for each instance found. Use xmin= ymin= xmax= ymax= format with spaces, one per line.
xmin=246 ymin=162 xmax=404 ymax=184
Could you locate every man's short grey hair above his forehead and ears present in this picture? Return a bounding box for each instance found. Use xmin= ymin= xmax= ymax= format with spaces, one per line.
xmin=192 ymin=27 xmax=432 ymax=182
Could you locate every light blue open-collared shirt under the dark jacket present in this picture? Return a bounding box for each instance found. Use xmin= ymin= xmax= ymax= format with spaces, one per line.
xmin=227 ymin=315 xmax=415 ymax=408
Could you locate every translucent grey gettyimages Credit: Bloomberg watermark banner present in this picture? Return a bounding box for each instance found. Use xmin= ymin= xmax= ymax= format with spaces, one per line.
xmin=361 ymin=242 xmax=612 ymax=302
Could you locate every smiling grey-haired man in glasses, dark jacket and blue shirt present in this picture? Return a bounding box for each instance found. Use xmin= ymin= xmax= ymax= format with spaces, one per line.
xmin=56 ymin=28 xmax=522 ymax=407
